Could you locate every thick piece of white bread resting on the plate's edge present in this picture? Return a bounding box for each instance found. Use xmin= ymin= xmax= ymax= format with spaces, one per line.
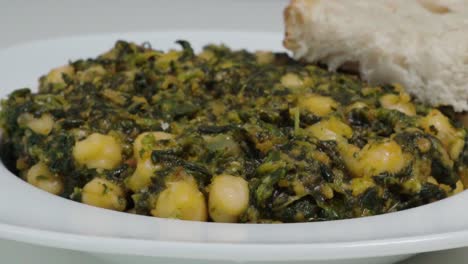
xmin=284 ymin=0 xmax=468 ymax=111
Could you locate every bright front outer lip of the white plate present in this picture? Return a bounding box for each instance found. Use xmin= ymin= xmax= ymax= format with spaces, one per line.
xmin=0 ymin=223 xmax=468 ymax=261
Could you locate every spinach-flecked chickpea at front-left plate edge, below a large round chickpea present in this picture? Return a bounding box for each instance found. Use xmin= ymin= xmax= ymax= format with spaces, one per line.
xmin=81 ymin=177 xmax=127 ymax=211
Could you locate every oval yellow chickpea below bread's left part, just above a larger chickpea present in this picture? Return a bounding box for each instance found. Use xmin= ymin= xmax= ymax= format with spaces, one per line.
xmin=298 ymin=94 xmax=338 ymax=116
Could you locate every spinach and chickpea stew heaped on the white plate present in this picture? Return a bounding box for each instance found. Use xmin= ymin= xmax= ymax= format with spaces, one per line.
xmin=0 ymin=41 xmax=468 ymax=223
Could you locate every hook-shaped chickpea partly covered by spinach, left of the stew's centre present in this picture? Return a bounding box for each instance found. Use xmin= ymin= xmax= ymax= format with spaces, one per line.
xmin=133 ymin=131 xmax=174 ymax=160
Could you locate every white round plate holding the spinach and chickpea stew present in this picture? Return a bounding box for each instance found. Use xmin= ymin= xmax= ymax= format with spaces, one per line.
xmin=0 ymin=31 xmax=468 ymax=263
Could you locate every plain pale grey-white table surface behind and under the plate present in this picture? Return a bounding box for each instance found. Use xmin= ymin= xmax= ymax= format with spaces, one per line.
xmin=0 ymin=0 xmax=468 ymax=264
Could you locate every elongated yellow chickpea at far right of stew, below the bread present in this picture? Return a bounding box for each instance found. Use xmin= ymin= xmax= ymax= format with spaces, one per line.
xmin=421 ymin=109 xmax=465 ymax=160
